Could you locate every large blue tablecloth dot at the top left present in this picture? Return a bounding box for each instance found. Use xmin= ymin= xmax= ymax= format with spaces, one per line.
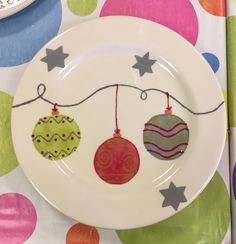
xmin=0 ymin=0 xmax=62 ymax=67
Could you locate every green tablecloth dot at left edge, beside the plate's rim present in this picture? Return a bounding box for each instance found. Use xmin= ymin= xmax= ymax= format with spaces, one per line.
xmin=0 ymin=91 xmax=18 ymax=176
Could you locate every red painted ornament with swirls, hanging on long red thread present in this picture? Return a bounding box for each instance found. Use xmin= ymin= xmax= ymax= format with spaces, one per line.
xmin=94 ymin=85 xmax=140 ymax=184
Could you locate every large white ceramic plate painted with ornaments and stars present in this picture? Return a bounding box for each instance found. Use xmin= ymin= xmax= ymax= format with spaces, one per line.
xmin=12 ymin=17 xmax=226 ymax=229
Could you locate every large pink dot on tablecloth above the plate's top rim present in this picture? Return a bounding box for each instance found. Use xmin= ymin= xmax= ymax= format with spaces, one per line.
xmin=100 ymin=0 xmax=198 ymax=45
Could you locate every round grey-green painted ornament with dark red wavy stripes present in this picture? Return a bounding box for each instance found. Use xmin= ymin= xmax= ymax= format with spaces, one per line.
xmin=143 ymin=114 xmax=189 ymax=160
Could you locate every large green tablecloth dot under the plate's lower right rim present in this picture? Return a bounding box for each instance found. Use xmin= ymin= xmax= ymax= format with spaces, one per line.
xmin=117 ymin=173 xmax=230 ymax=244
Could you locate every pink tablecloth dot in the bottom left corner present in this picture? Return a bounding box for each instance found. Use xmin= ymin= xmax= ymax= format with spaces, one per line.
xmin=0 ymin=193 xmax=37 ymax=244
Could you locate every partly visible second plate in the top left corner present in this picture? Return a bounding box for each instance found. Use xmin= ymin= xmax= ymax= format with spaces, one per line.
xmin=0 ymin=0 xmax=35 ymax=19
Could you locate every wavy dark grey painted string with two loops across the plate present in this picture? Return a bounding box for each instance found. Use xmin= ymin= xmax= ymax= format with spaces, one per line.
xmin=12 ymin=83 xmax=224 ymax=115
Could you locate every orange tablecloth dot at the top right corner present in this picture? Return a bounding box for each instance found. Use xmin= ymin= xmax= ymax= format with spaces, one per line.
xmin=199 ymin=0 xmax=226 ymax=16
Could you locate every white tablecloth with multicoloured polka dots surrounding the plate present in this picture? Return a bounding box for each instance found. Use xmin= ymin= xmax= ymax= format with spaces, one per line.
xmin=0 ymin=0 xmax=232 ymax=244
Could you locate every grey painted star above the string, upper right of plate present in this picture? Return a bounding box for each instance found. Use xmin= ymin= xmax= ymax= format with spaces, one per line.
xmin=132 ymin=52 xmax=156 ymax=76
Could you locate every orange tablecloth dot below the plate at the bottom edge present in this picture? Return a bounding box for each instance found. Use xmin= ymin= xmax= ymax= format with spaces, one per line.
xmin=66 ymin=224 xmax=99 ymax=244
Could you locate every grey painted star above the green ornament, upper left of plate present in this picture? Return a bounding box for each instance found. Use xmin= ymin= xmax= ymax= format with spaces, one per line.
xmin=40 ymin=46 xmax=69 ymax=72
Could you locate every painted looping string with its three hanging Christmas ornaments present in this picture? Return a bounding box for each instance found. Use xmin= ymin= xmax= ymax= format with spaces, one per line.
xmin=12 ymin=80 xmax=224 ymax=168
